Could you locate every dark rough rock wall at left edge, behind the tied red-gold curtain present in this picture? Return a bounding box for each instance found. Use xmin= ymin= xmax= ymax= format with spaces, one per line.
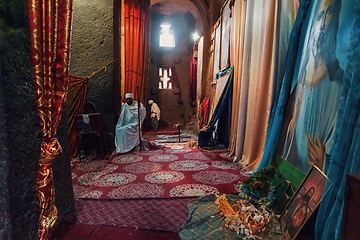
xmin=0 ymin=0 xmax=73 ymax=240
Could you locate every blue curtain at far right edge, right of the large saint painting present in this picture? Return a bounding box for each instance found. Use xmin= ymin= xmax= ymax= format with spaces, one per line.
xmin=315 ymin=1 xmax=360 ymax=240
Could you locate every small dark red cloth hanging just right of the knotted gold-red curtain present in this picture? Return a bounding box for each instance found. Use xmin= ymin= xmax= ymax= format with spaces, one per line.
xmin=66 ymin=75 xmax=88 ymax=159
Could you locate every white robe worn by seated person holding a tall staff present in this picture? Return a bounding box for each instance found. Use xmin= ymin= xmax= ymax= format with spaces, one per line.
xmin=115 ymin=101 xmax=146 ymax=153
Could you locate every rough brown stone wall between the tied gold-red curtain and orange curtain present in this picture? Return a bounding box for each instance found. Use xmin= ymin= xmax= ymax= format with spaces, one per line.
xmin=70 ymin=0 xmax=117 ymax=133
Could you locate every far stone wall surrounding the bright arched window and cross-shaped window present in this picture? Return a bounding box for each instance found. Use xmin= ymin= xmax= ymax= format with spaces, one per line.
xmin=147 ymin=12 xmax=195 ymax=124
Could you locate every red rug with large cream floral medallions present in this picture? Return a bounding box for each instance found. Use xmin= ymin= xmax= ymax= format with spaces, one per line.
xmin=72 ymin=143 xmax=245 ymax=199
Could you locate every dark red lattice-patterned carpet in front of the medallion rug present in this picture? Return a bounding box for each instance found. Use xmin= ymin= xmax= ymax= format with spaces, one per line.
xmin=64 ymin=198 xmax=192 ymax=232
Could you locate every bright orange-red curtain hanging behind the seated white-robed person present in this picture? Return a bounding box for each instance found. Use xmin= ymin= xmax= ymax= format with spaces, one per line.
xmin=121 ymin=0 xmax=150 ymax=102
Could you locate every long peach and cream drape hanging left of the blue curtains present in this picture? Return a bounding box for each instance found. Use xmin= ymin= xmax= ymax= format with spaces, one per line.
xmin=230 ymin=0 xmax=280 ymax=170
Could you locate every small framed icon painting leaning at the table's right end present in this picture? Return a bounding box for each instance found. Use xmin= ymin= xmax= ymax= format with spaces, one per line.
xmin=280 ymin=165 xmax=331 ymax=240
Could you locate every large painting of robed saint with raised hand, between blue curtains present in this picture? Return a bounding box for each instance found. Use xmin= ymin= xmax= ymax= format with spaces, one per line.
xmin=282 ymin=0 xmax=343 ymax=172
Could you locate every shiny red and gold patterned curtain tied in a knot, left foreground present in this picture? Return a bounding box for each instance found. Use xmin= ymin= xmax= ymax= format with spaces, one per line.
xmin=27 ymin=0 xmax=72 ymax=239
